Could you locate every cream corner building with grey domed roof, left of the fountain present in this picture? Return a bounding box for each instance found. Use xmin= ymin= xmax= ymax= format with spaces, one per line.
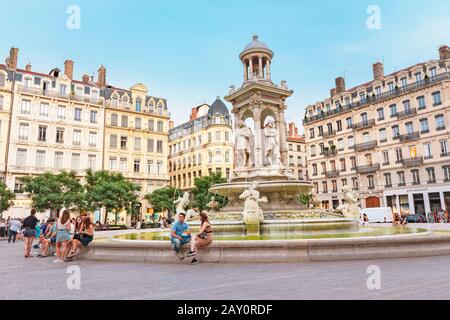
xmin=169 ymin=97 xmax=234 ymax=191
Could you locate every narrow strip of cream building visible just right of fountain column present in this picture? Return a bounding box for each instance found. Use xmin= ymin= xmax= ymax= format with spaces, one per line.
xmin=286 ymin=122 xmax=308 ymax=181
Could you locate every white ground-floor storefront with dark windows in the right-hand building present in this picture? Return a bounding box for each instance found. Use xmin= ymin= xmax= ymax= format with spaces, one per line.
xmin=383 ymin=185 xmax=450 ymax=215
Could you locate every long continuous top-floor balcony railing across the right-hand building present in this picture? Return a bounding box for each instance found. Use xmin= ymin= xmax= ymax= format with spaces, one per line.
xmin=303 ymin=73 xmax=450 ymax=125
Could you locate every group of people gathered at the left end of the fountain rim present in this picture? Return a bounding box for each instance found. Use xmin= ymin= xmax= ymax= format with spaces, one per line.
xmin=9 ymin=209 xmax=94 ymax=263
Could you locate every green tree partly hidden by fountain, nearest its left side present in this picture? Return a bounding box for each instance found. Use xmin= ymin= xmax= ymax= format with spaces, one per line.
xmin=192 ymin=173 xmax=228 ymax=211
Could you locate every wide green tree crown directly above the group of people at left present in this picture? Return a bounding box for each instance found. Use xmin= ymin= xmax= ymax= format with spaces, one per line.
xmin=21 ymin=172 xmax=85 ymax=213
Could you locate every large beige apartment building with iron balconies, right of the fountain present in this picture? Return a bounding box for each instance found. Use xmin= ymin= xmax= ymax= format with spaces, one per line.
xmin=304 ymin=46 xmax=450 ymax=214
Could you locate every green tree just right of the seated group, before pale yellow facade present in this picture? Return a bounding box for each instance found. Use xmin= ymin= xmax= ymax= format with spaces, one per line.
xmin=85 ymin=170 xmax=141 ymax=224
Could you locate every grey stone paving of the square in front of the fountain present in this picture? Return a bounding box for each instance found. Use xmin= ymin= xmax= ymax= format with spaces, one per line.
xmin=0 ymin=225 xmax=450 ymax=300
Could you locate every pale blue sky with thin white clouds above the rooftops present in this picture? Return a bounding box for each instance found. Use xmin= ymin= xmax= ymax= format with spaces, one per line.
xmin=0 ymin=0 xmax=450 ymax=131
